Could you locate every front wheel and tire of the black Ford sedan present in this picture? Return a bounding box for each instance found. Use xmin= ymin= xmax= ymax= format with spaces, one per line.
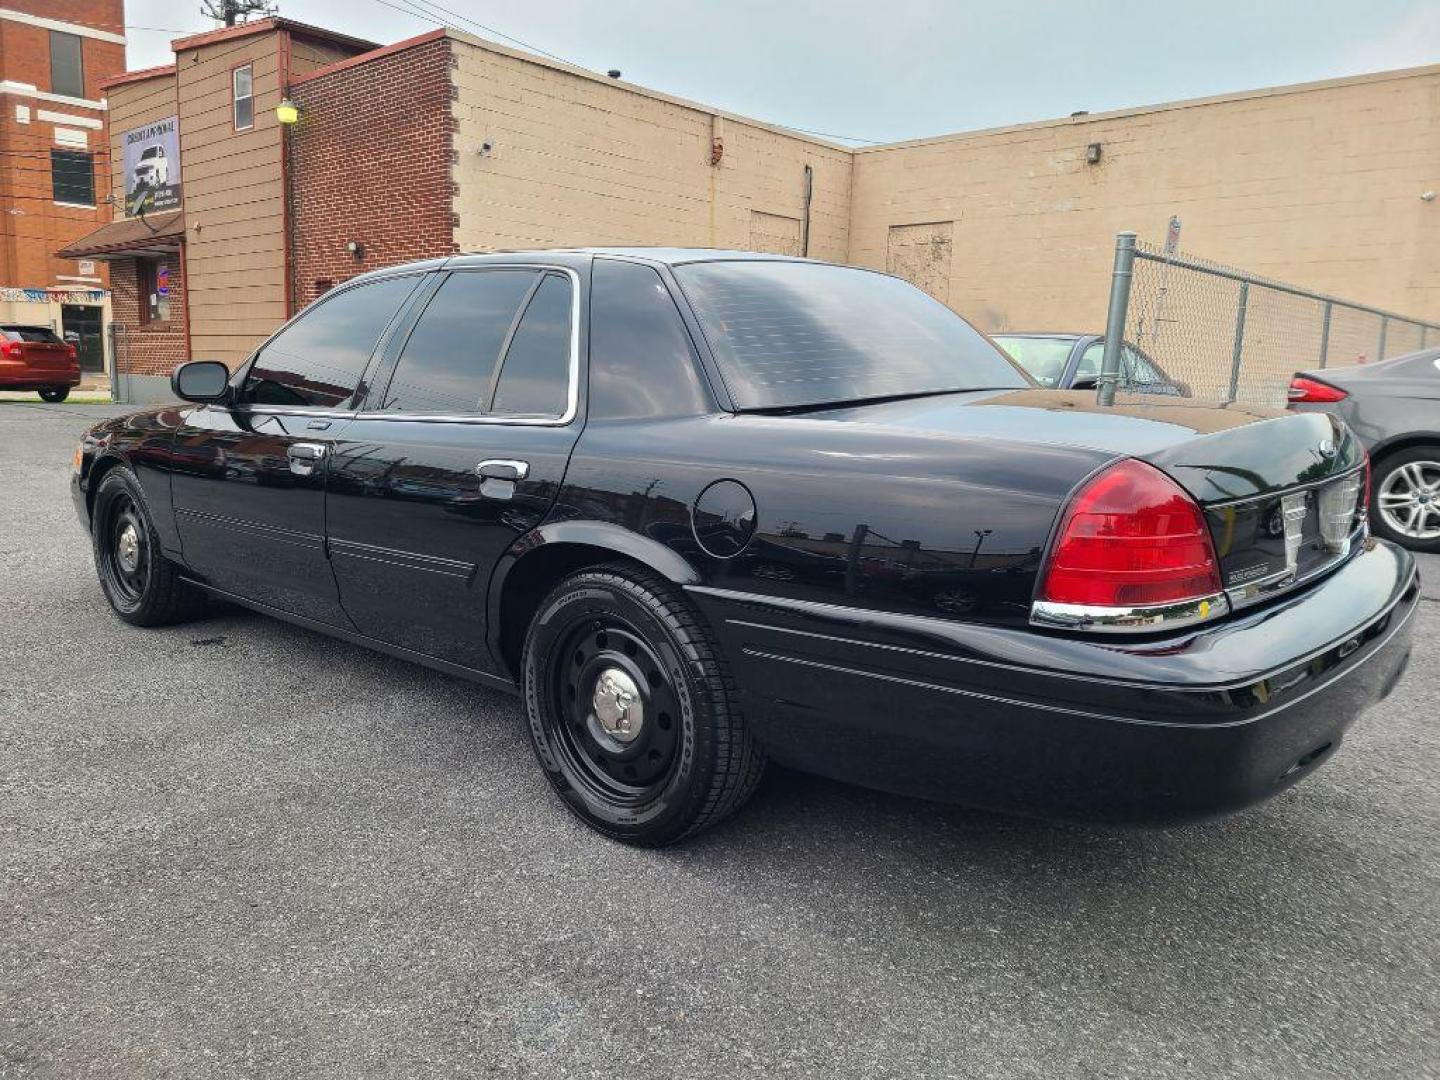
xmin=91 ymin=465 xmax=204 ymax=626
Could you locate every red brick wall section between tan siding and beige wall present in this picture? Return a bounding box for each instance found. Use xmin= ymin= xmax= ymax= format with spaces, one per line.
xmin=289 ymin=39 xmax=455 ymax=310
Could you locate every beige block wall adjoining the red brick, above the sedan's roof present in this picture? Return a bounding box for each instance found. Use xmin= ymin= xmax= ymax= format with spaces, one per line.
xmin=452 ymin=35 xmax=851 ymax=261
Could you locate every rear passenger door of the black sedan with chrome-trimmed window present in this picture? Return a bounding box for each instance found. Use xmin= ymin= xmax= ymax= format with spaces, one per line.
xmin=327 ymin=265 xmax=582 ymax=670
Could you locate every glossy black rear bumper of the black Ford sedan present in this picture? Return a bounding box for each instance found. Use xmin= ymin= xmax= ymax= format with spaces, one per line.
xmin=694 ymin=541 xmax=1418 ymax=824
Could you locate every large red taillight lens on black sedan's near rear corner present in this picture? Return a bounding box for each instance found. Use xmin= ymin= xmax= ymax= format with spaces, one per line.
xmin=1040 ymin=458 xmax=1220 ymax=608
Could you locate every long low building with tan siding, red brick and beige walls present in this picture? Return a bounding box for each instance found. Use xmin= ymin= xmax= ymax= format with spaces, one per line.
xmin=63 ymin=19 xmax=1440 ymax=399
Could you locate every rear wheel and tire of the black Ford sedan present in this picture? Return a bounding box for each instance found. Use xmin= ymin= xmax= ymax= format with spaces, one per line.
xmin=523 ymin=566 xmax=765 ymax=847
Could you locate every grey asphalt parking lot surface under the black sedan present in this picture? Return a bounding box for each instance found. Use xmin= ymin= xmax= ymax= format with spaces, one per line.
xmin=0 ymin=402 xmax=1440 ymax=1080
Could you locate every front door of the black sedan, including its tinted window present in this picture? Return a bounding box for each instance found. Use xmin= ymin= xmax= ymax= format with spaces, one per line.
xmin=170 ymin=274 xmax=420 ymax=626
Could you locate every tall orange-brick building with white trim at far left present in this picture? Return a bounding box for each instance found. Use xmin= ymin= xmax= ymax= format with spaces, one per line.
xmin=0 ymin=0 xmax=125 ymax=376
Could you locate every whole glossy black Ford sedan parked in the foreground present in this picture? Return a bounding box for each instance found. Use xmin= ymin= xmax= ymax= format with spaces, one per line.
xmin=73 ymin=249 xmax=1418 ymax=844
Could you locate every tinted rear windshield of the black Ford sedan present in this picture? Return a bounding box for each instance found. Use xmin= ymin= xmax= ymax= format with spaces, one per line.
xmin=675 ymin=261 xmax=1028 ymax=409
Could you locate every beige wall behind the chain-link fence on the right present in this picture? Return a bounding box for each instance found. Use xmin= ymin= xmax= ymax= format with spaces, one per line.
xmin=848 ymin=66 xmax=1440 ymax=330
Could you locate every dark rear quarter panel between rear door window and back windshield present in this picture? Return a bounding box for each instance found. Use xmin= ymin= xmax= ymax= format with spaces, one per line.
xmin=589 ymin=259 xmax=711 ymax=419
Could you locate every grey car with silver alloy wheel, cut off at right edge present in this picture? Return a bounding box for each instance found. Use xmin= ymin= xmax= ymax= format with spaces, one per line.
xmin=1290 ymin=348 xmax=1440 ymax=552
